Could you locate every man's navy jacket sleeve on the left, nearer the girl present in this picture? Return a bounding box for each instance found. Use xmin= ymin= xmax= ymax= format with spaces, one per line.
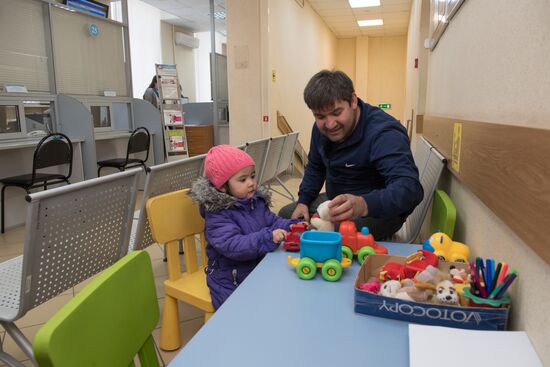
xmin=298 ymin=125 xmax=326 ymax=206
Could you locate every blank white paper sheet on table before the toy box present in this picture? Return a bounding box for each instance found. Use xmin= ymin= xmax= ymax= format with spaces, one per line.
xmin=409 ymin=324 xmax=542 ymax=367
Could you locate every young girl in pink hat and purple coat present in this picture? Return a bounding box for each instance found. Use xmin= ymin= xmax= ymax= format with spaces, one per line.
xmin=190 ymin=145 xmax=301 ymax=309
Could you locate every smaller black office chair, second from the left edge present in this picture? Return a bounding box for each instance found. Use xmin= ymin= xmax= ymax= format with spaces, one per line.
xmin=97 ymin=127 xmax=151 ymax=177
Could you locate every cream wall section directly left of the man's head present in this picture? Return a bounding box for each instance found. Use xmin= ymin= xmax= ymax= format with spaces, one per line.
xmin=268 ymin=0 xmax=338 ymax=151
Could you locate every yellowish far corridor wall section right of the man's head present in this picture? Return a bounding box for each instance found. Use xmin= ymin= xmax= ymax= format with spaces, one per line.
xmin=368 ymin=36 xmax=410 ymax=123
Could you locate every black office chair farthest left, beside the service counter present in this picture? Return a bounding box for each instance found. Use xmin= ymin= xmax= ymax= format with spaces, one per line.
xmin=0 ymin=133 xmax=73 ymax=233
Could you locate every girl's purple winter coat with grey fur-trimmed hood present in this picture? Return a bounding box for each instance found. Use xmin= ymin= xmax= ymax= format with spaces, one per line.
xmin=190 ymin=177 xmax=301 ymax=309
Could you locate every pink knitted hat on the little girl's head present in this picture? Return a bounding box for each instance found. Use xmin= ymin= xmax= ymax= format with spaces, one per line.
xmin=204 ymin=144 xmax=255 ymax=189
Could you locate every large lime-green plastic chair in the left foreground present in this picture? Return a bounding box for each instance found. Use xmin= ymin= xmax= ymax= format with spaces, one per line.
xmin=33 ymin=251 xmax=159 ymax=367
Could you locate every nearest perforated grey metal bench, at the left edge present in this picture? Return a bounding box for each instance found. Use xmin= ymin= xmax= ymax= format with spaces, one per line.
xmin=0 ymin=169 xmax=141 ymax=366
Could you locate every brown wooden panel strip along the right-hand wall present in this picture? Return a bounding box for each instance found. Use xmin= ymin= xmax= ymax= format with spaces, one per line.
xmin=423 ymin=116 xmax=550 ymax=264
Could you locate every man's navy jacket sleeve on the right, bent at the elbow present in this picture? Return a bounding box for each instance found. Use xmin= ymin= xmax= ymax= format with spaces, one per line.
xmin=363 ymin=128 xmax=424 ymax=218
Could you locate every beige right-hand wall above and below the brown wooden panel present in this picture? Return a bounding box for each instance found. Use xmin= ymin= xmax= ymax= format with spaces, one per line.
xmin=413 ymin=0 xmax=550 ymax=365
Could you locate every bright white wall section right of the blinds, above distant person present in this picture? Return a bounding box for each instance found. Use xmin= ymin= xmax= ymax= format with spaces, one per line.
xmin=128 ymin=0 xmax=162 ymax=98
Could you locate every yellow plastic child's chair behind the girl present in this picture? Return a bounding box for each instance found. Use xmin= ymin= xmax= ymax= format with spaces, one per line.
xmin=146 ymin=189 xmax=214 ymax=350
